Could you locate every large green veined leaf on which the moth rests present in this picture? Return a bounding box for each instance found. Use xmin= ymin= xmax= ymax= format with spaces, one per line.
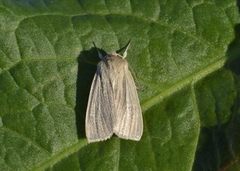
xmin=0 ymin=0 xmax=238 ymax=171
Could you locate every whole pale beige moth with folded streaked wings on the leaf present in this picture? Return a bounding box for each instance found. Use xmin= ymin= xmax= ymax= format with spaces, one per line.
xmin=85 ymin=41 xmax=143 ymax=143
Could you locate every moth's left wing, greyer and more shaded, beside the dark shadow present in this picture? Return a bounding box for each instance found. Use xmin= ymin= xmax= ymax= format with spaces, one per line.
xmin=85 ymin=62 xmax=113 ymax=142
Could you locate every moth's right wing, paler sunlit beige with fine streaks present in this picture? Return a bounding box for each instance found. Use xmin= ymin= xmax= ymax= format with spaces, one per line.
xmin=113 ymin=69 xmax=143 ymax=141
